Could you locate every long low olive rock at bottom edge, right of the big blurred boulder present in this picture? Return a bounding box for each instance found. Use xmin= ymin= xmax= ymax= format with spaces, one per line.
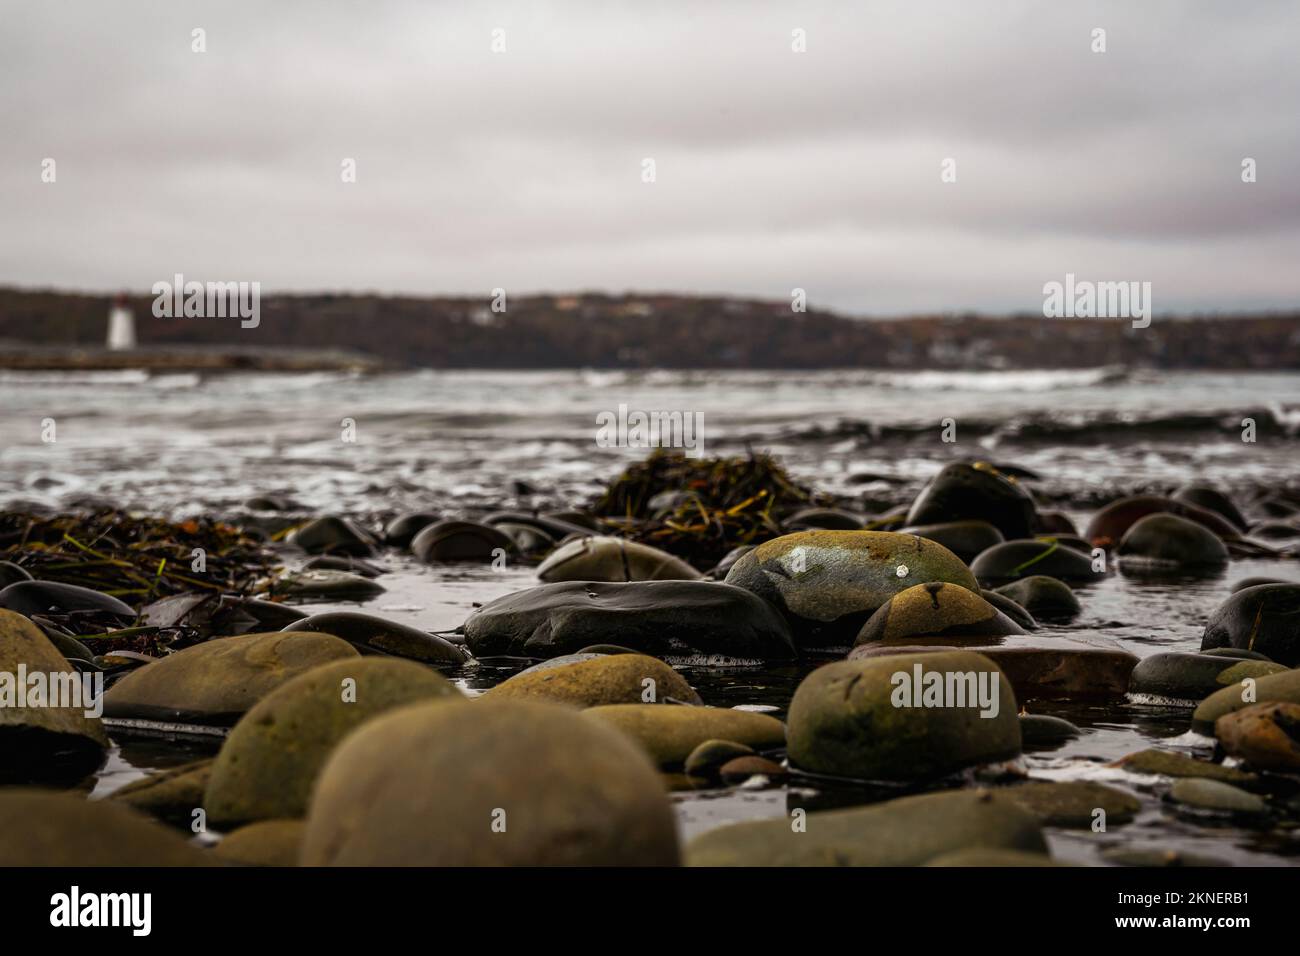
xmin=686 ymin=790 xmax=1047 ymax=866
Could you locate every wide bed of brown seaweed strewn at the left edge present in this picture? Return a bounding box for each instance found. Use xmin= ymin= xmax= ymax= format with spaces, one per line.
xmin=0 ymin=510 xmax=280 ymax=656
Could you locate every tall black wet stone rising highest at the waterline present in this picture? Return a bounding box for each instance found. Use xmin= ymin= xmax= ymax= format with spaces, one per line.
xmin=907 ymin=462 xmax=1035 ymax=540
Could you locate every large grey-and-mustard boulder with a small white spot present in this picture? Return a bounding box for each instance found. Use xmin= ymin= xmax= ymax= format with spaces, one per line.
xmin=727 ymin=531 xmax=979 ymax=653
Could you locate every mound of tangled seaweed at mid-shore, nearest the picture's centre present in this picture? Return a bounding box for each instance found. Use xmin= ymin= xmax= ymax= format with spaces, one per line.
xmin=592 ymin=449 xmax=820 ymax=570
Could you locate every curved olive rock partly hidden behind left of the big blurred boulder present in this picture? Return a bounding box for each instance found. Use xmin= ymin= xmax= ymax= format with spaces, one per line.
xmin=204 ymin=657 xmax=464 ymax=825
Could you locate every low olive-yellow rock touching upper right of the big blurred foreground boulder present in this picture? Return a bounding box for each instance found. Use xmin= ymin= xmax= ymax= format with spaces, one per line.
xmin=582 ymin=704 xmax=785 ymax=767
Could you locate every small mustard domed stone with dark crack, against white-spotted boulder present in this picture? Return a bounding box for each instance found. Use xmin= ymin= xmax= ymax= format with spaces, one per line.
xmin=855 ymin=581 xmax=1024 ymax=644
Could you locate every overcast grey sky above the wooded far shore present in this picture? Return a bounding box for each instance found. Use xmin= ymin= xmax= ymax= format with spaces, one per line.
xmin=0 ymin=0 xmax=1300 ymax=315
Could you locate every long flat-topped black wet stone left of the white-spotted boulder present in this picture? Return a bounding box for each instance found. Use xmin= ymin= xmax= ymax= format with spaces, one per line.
xmin=464 ymin=581 xmax=797 ymax=662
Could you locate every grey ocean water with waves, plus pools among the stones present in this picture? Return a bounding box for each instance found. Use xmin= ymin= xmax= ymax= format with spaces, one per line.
xmin=0 ymin=368 xmax=1300 ymax=865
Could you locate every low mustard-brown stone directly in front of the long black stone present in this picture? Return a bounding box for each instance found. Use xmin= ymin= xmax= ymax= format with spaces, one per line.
xmin=484 ymin=654 xmax=701 ymax=708
